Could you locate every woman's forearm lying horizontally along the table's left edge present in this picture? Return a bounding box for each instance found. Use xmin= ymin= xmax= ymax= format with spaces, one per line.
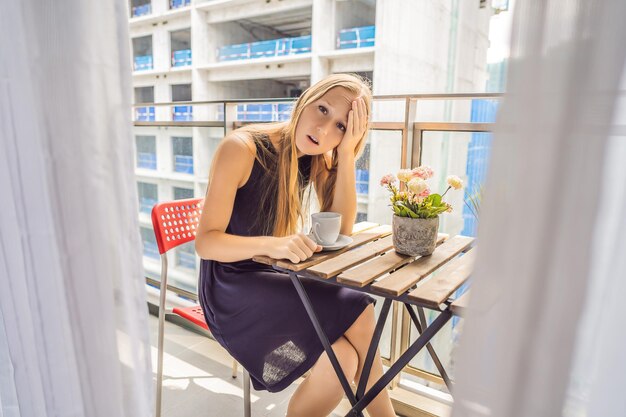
xmin=196 ymin=230 xmax=273 ymax=262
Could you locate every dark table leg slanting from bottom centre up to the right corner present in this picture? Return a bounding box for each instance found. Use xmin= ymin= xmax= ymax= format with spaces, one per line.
xmin=346 ymin=309 xmax=452 ymax=416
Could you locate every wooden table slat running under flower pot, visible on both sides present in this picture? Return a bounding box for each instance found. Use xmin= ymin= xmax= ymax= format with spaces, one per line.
xmin=337 ymin=233 xmax=448 ymax=287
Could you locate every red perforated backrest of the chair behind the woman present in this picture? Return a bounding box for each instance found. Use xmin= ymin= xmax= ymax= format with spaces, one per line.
xmin=152 ymin=198 xmax=204 ymax=255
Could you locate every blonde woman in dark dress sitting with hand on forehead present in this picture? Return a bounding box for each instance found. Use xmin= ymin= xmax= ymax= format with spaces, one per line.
xmin=196 ymin=74 xmax=395 ymax=417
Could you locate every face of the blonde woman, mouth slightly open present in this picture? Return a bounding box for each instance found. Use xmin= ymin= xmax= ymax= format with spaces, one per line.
xmin=296 ymin=87 xmax=356 ymax=155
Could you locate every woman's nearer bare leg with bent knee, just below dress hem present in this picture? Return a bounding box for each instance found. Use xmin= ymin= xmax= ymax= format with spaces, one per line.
xmin=287 ymin=337 xmax=359 ymax=417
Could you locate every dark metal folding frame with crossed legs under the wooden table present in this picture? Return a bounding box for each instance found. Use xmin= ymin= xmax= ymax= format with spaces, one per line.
xmin=274 ymin=266 xmax=452 ymax=417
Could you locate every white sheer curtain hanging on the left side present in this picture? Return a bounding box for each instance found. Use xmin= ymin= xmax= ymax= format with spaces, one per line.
xmin=0 ymin=0 xmax=153 ymax=417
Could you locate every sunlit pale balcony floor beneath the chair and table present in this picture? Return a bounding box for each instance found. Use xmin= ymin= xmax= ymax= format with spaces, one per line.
xmin=149 ymin=315 xmax=360 ymax=417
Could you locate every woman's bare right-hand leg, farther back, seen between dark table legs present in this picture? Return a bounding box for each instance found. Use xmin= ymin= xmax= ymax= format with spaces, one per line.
xmin=344 ymin=304 xmax=396 ymax=417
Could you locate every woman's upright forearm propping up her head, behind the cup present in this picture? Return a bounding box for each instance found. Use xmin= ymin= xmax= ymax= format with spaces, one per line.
xmin=331 ymin=153 xmax=356 ymax=236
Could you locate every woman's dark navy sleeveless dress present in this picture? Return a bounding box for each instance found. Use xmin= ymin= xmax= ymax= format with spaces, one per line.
xmin=198 ymin=137 xmax=374 ymax=392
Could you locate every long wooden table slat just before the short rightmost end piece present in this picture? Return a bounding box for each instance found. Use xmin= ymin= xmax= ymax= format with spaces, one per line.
xmin=409 ymin=249 xmax=476 ymax=308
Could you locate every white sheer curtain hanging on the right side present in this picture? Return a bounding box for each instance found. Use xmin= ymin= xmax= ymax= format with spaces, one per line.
xmin=453 ymin=0 xmax=626 ymax=417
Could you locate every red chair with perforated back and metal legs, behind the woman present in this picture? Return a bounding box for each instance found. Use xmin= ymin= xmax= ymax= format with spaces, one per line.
xmin=152 ymin=198 xmax=251 ymax=417
